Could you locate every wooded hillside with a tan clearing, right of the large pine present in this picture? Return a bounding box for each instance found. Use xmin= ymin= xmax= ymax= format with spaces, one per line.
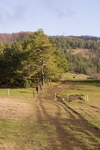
xmin=52 ymin=36 xmax=100 ymax=75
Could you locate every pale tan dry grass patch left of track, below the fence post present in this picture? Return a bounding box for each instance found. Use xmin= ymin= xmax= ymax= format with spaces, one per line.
xmin=0 ymin=97 xmax=33 ymax=120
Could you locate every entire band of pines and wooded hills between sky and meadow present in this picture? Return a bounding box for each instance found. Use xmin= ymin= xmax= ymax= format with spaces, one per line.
xmin=0 ymin=30 xmax=100 ymax=87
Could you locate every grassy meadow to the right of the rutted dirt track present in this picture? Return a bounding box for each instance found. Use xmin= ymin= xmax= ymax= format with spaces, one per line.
xmin=58 ymin=73 xmax=100 ymax=130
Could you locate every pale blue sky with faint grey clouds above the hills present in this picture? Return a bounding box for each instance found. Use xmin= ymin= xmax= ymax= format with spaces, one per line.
xmin=0 ymin=0 xmax=100 ymax=37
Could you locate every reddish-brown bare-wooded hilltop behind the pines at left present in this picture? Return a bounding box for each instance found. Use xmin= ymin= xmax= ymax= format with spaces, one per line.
xmin=0 ymin=32 xmax=34 ymax=45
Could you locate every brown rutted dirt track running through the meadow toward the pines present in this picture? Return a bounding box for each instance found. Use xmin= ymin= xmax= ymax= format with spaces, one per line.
xmin=35 ymin=86 xmax=100 ymax=150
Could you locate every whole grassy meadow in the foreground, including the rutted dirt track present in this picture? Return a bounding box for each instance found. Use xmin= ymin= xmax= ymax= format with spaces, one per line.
xmin=0 ymin=73 xmax=100 ymax=150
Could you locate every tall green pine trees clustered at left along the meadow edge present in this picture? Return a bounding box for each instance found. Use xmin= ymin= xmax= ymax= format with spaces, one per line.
xmin=0 ymin=30 xmax=68 ymax=87
